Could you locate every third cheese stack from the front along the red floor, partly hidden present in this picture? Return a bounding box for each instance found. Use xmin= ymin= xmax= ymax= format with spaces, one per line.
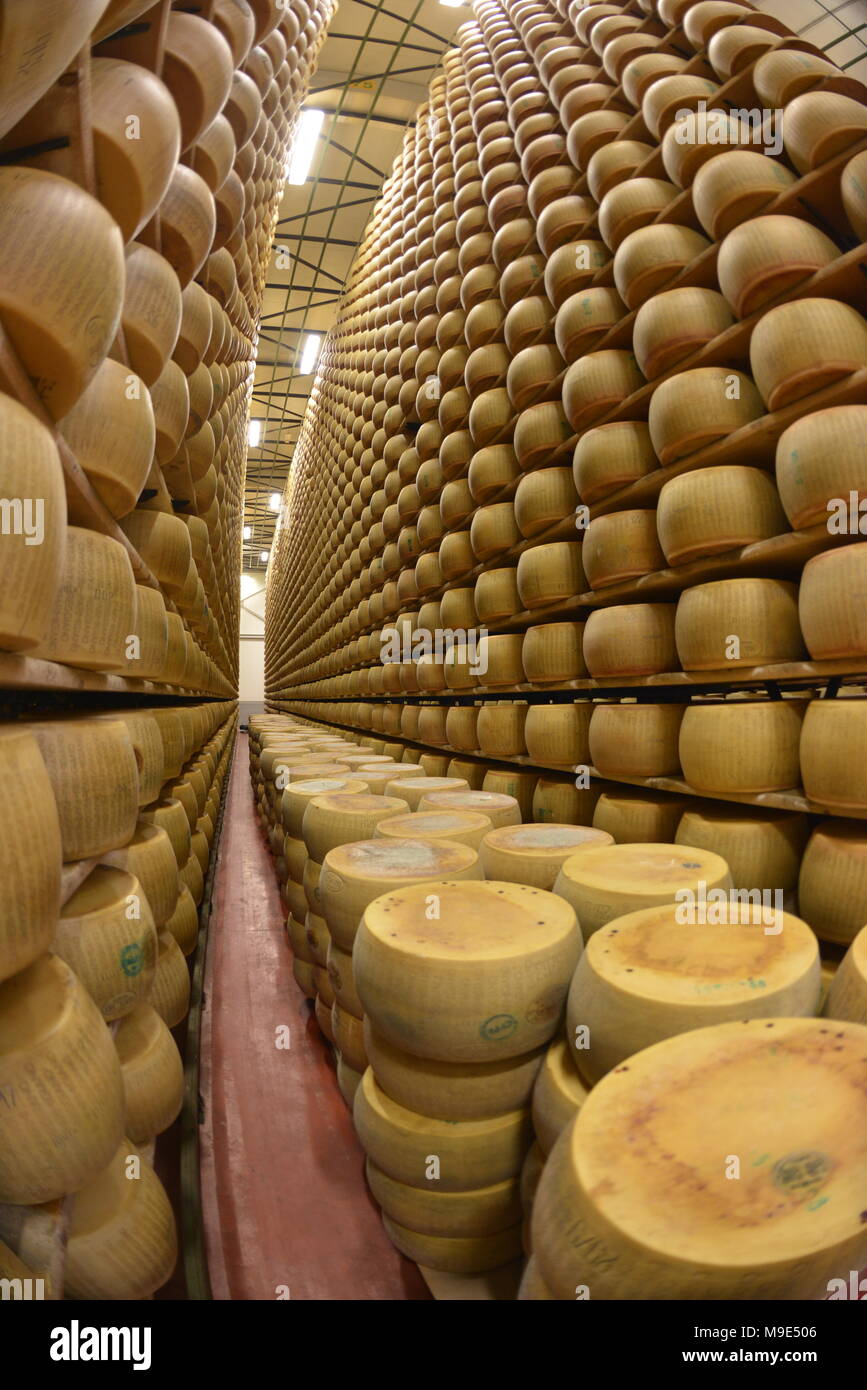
xmin=297 ymin=780 xmax=407 ymax=1045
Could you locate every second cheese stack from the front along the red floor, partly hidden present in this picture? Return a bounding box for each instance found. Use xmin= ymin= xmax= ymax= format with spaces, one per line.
xmin=318 ymin=834 xmax=489 ymax=1104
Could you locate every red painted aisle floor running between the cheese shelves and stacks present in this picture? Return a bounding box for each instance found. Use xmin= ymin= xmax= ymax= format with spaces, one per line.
xmin=200 ymin=734 xmax=431 ymax=1301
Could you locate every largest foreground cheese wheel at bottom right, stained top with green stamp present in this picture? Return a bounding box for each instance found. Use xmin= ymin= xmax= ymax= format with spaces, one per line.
xmin=532 ymin=1017 xmax=867 ymax=1300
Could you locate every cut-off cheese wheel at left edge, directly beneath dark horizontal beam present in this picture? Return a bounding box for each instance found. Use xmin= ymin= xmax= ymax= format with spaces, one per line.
xmin=0 ymin=724 xmax=61 ymax=980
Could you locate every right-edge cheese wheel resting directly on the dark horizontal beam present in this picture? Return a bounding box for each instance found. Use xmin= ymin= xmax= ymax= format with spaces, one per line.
xmin=798 ymin=542 xmax=867 ymax=662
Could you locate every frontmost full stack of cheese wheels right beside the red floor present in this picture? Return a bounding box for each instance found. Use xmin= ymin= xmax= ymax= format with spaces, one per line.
xmin=353 ymin=880 xmax=581 ymax=1275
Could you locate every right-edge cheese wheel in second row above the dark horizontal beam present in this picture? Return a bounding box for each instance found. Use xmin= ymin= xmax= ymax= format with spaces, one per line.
xmin=777 ymin=406 xmax=867 ymax=531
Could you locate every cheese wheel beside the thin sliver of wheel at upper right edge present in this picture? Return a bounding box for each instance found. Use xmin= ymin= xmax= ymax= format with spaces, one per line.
xmin=717 ymin=215 xmax=839 ymax=318
